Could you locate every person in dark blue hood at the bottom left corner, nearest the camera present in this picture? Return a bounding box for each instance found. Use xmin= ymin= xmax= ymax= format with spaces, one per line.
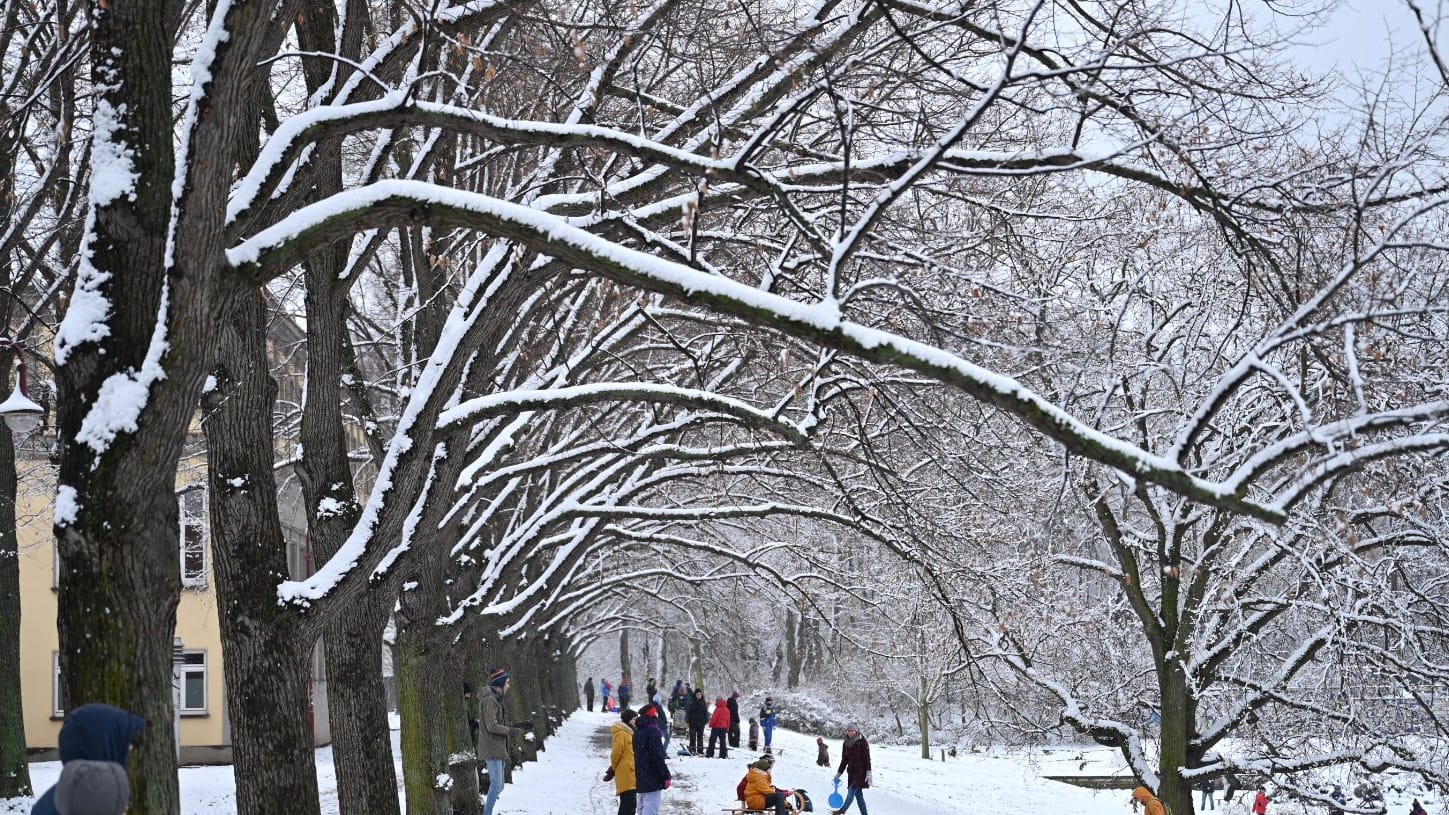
xmin=30 ymin=705 xmax=146 ymax=815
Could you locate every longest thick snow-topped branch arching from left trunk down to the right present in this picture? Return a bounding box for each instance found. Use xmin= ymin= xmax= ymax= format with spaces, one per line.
xmin=227 ymin=181 xmax=1284 ymax=524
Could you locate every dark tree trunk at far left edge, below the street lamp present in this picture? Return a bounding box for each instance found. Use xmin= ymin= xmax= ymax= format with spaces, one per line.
xmin=0 ymin=406 xmax=30 ymax=799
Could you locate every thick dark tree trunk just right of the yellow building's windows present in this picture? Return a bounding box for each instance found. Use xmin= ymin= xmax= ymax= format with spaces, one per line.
xmin=201 ymin=281 xmax=320 ymax=815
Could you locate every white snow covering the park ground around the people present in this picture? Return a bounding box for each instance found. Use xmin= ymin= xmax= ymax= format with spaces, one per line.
xmin=0 ymin=712 xmax=1449 ymax=815
